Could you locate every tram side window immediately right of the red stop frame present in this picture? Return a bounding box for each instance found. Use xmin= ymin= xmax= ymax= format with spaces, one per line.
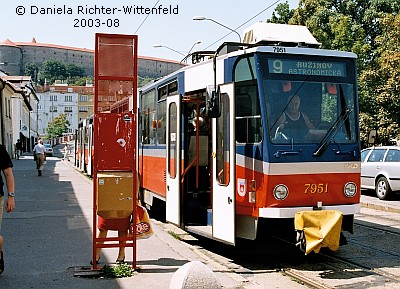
xmin=141 ymin=90 xmax=157 ymax=144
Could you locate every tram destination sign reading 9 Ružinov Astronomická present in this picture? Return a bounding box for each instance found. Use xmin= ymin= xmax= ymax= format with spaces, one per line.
xmin=268 ymin=59 xmax=346 ymax=77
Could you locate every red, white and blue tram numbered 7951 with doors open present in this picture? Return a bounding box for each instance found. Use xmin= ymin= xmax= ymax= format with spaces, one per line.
xmin=138 ymin=23 xmax=360 ymax=252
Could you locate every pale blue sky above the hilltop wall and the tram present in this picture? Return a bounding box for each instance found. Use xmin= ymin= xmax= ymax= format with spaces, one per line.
xmin=0 ymin=0 xmax=299 ymax=61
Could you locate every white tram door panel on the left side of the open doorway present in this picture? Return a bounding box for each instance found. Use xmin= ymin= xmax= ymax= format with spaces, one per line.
xmin=166 ymin=94 xmax=181 ymax=226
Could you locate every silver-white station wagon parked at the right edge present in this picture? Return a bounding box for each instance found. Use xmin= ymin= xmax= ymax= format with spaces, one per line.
xmin=361 ymin=146 xmax=400 ymax=200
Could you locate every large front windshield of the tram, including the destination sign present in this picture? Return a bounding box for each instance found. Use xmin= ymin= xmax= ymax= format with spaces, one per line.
xmin=259 ymin=56 xmax=357 ymax=144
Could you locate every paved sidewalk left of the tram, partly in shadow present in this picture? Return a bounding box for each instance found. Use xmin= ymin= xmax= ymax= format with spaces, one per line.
xmin=0 ymin=154 xmax=241 ymax=289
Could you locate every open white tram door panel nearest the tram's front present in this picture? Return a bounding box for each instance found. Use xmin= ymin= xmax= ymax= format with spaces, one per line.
xmin=212 ymin=84 xmax=236 ymax=245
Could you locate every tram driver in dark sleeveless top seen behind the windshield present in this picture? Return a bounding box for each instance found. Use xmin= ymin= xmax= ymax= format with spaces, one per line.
xmin=275 ymin=95 xmax=314 ymax=141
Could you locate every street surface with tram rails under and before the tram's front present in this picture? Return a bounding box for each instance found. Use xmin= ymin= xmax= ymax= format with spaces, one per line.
xmin=169 ymin=208 xmax=400 ymax=289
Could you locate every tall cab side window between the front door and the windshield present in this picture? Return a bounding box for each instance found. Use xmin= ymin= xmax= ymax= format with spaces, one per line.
xmin=234 ymin=57 xmax=262 ymax=143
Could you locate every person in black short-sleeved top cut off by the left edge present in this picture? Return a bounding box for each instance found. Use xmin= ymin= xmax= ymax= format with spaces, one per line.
xmin=0 ymin=145 xmax=15 ymax=274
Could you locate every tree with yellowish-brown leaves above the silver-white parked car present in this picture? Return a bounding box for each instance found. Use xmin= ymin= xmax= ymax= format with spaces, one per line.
xmin=360 ymin=14 xmax=400 ymax=144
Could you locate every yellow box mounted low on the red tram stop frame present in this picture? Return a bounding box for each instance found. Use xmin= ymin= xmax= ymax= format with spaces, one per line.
xmin=97 ymin=172 xmax=133 ymax=219
